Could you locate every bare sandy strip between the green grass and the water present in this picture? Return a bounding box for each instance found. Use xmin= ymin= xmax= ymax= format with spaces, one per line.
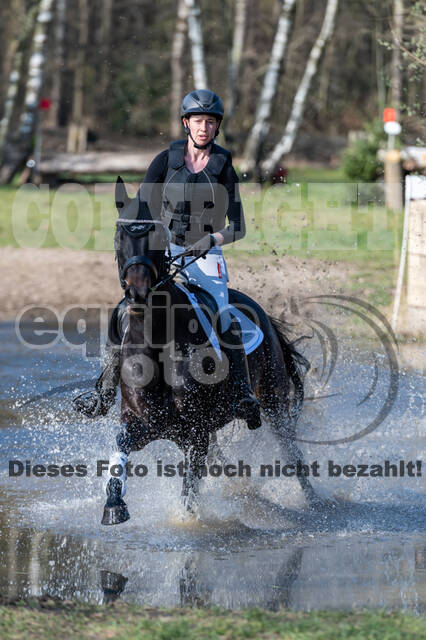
xmin=0 ymin=247 xmax=356 ymax=321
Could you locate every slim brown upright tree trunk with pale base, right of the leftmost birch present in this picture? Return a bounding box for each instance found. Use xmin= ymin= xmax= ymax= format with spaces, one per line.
xmin=67 ymin=0 xmax=89 ymax=153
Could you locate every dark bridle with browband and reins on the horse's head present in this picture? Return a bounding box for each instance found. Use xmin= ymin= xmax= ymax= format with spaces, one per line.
xmin=116 ymin=218 xmax=209 ymax=291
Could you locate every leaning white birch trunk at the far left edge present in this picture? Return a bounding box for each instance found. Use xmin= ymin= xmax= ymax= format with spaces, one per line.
xmin=0 ymin=0 xmax=52 ymax=184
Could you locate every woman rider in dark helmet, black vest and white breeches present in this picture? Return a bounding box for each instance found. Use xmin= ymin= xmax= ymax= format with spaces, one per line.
xmin=74 ymin=89 xmax=260 ymax=429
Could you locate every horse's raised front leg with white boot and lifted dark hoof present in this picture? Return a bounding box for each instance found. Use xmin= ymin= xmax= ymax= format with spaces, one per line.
xmin=102 ymin=424 xmax=132 ymax=525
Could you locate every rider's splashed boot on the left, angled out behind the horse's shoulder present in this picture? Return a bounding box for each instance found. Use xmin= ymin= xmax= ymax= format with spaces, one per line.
xmin=72 ymin=340 xmax=120 ymax=418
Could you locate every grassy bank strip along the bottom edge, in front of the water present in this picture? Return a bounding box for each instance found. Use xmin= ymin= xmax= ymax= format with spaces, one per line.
xmin=0 ymin=598 xmax=426 ymax=640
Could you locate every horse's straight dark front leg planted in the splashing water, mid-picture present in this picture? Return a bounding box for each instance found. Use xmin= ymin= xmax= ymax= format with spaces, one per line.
xmin=181 ymin=431 xmax=209 ymax=515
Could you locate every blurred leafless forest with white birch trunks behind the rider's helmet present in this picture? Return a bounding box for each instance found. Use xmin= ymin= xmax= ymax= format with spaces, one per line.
xmin=0 ymin=0 xmax=426 ymax=182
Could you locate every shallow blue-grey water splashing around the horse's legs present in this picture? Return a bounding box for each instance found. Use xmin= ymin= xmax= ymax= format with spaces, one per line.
xmin=0 ymin=324 xmax=426 ymax=612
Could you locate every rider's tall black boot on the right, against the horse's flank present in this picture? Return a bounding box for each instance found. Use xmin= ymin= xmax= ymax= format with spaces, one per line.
xmin=222 ymin=318 xmax=262 ymax=429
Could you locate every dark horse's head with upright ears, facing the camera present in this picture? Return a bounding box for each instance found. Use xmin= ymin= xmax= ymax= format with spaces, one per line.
xmin=114 ymin=177 xmax=170 ymax=306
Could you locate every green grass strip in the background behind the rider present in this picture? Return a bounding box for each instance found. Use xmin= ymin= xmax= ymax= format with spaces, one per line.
xmin=0 ymin=168 xmax=402 ymax=305
